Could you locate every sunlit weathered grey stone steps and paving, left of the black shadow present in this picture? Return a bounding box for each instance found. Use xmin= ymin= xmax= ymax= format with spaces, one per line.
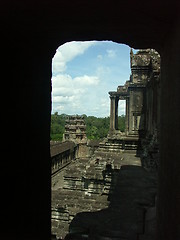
xmin=52 ymin=153 xmax=145 ymax=237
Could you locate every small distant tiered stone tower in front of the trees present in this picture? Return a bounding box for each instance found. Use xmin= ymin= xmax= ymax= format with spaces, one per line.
xmin=63 ymin=115 xmax=87 ymax=144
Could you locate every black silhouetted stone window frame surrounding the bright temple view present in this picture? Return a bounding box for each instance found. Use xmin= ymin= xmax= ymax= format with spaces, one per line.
xmin=0 ymin=0 xmax=180 ymax=240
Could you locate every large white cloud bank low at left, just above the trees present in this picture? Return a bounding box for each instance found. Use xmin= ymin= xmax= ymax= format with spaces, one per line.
xmin=52 ymin=74 xmax=99 ymax=114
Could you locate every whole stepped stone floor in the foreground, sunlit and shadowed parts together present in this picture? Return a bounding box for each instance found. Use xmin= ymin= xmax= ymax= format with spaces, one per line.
xmin=52 ymin=153 xmax=157 ymax=240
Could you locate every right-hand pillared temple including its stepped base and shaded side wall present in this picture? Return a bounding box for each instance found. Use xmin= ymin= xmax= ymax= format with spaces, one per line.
xmin=99 ymin=49 xmax=160 ymax=169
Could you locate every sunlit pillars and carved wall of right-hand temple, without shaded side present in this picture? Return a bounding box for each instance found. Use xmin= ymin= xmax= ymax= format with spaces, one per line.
xmin=109 ymin=49 xmax=160 ymax=138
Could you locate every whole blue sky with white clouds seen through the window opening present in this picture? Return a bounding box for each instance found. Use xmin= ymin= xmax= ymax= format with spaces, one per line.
xmin=52 ymin=41 xmax=136 ymax=117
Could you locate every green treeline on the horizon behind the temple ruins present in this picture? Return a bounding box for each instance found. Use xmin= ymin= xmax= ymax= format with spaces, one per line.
xmin=51 ymin=112 xmax=125 ymax=141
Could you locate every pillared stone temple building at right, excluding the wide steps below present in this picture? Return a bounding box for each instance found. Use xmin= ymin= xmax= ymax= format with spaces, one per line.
xmin=108 ymin=49 xmax=160 ymax=152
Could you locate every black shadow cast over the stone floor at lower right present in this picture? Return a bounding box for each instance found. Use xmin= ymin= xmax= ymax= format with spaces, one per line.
xmin=67 ymin=166 xmax=157 ymax=240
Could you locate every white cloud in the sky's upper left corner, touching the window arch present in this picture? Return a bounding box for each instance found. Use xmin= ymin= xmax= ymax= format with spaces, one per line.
xmin=52 ymin=41 xmax=96 ymax=75
